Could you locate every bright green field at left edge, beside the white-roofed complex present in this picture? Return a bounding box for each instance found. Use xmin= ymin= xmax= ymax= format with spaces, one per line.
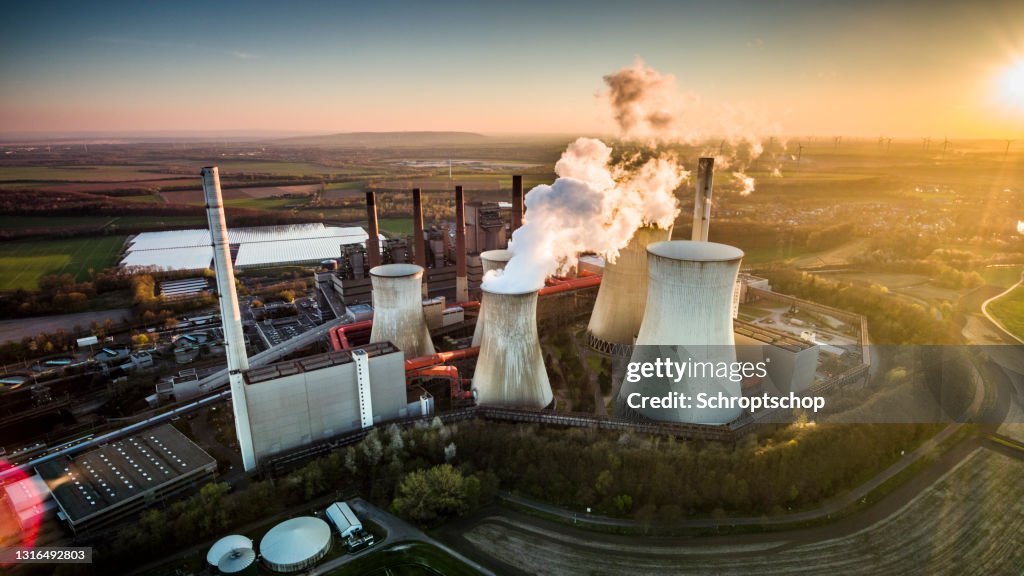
xmin=0 ymin=236 xmax=125 ymax=291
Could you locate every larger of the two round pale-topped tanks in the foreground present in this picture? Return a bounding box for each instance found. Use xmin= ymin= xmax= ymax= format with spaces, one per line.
xmin=259 ymin=516 xmax=331 ymax=573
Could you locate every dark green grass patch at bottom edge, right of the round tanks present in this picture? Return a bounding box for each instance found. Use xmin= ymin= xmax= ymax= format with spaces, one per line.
xmin=328 ymin=542 xmax=479 ymax=576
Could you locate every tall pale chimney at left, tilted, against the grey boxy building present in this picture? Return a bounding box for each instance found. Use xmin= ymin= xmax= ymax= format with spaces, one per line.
xmin=201 ymin=166 xmax=256 ymax=471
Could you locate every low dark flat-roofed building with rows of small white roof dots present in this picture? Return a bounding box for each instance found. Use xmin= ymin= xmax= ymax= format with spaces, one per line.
xmin=36 ymin=424 xmax=217 ymax=532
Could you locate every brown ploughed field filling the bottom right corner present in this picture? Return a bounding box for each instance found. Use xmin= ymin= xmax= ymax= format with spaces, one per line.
xmin=466 ymin=449 xmax=1024 ymax=575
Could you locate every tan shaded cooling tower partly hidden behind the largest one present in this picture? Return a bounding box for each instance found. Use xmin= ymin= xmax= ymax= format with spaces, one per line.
xmin=587 ymin=227 xmax=672 ymax=356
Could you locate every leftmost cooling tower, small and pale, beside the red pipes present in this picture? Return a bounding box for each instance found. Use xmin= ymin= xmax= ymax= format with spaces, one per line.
xmin=370 ymin=264 xmax=434 ymax=358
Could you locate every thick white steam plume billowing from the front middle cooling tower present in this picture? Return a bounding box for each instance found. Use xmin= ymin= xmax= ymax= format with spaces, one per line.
xmin=483 ymin=138 xmax=687 ymax=293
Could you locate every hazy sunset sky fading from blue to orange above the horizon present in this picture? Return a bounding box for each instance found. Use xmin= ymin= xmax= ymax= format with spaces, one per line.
xmin=0 ymin=0 xmax=1024 ymax=137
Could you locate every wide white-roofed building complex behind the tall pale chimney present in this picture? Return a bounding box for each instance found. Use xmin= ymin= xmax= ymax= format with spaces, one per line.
xmin=121 ymin=222 xmax=384 ymax=270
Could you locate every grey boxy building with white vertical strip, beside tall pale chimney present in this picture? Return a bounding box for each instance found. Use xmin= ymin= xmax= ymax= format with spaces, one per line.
xmin=245 ymin=342 xmax=408 ymax=461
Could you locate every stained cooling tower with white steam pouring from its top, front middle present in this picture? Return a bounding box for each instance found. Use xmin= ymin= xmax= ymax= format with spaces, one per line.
xmin=473 ymin=287 xmax=553 ymax=408
